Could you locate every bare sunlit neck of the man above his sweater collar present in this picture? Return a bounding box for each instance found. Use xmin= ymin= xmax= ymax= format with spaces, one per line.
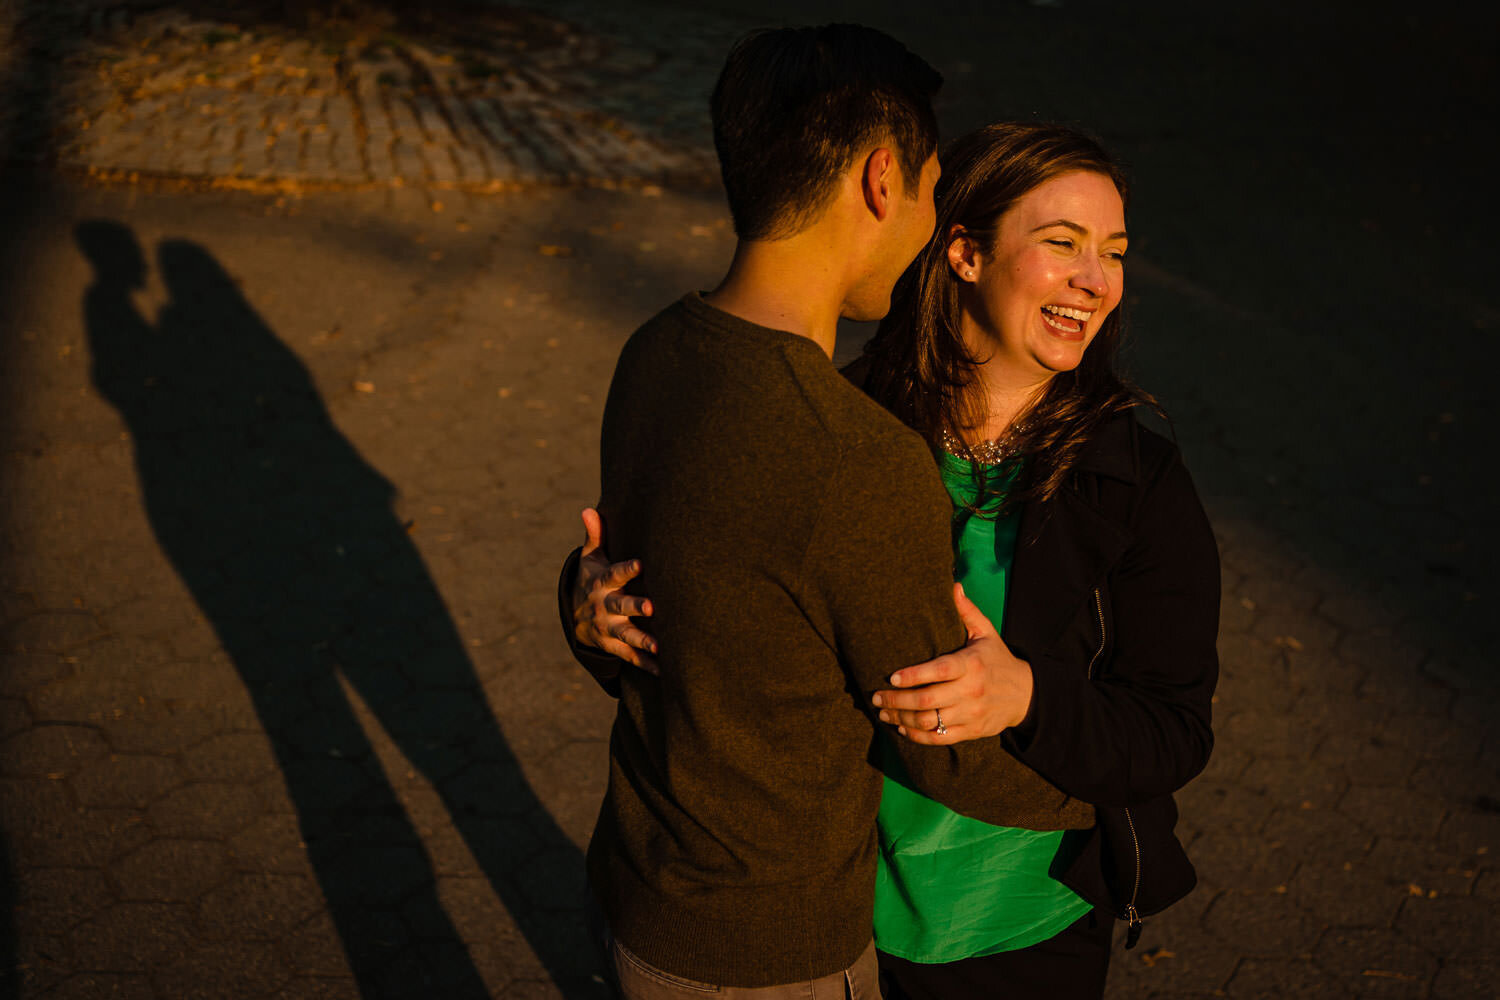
xmin=704 ymin=235 xmax=848 ymax=358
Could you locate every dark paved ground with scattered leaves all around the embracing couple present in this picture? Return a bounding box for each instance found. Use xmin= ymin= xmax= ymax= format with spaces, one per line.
xmin=0 ymin=0 xmax=1500 ymax=1000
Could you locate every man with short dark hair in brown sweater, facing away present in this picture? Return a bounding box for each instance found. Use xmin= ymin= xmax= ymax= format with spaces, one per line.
xmin=563 ymin=25 xmax=1029 ymax=1000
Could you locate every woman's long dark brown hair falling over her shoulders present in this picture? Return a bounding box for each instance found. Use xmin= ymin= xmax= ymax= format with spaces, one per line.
xmin=864 ymin=121 xmax=1160 ymax=516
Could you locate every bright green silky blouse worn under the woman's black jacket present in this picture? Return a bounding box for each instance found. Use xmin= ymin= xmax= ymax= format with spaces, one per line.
xmin=875 ymin=454 xmax=1089 ymax=963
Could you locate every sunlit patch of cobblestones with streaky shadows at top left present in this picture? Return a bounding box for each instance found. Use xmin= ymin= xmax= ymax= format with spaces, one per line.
xmin=0 ymin=1 xmax=744 ymax=190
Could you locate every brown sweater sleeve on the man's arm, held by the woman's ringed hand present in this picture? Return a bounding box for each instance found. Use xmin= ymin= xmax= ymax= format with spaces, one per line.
xmin=804 ymin=435 xmax=1038 ymax=823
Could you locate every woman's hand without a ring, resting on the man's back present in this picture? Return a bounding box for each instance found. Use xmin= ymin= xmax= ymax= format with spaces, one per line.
xmin=573 ymin=507 xmax=657 ymax=673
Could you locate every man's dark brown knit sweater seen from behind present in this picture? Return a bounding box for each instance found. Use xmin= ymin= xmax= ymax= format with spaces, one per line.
xmin=588 ymin=294 xmax=1016 ymax=987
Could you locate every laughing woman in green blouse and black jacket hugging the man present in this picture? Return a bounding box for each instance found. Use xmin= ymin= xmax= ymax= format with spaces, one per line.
xmin=572 ymin=124 xmax=1218 ymax=1000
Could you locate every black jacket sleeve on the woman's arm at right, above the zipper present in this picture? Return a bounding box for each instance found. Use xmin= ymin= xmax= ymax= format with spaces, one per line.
xmin=1002 ymin=450 xmax=1220 ymax=805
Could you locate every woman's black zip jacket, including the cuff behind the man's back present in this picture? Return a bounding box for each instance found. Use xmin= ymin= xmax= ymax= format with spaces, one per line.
xmin=558 ymin=414 xmax=1220 ymax=942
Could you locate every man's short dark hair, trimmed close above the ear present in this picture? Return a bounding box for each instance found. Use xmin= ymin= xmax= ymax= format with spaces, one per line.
xmin=711 ymin=24 xmax=942 ymax=240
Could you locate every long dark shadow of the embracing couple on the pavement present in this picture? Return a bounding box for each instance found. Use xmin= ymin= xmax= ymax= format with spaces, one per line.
xmin=75 ymin=220 xmax=603 ymax=997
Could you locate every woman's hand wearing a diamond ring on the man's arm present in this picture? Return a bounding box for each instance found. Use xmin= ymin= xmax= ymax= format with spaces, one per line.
xmin=870 ymin=583 xmax=1032 ymax=747
